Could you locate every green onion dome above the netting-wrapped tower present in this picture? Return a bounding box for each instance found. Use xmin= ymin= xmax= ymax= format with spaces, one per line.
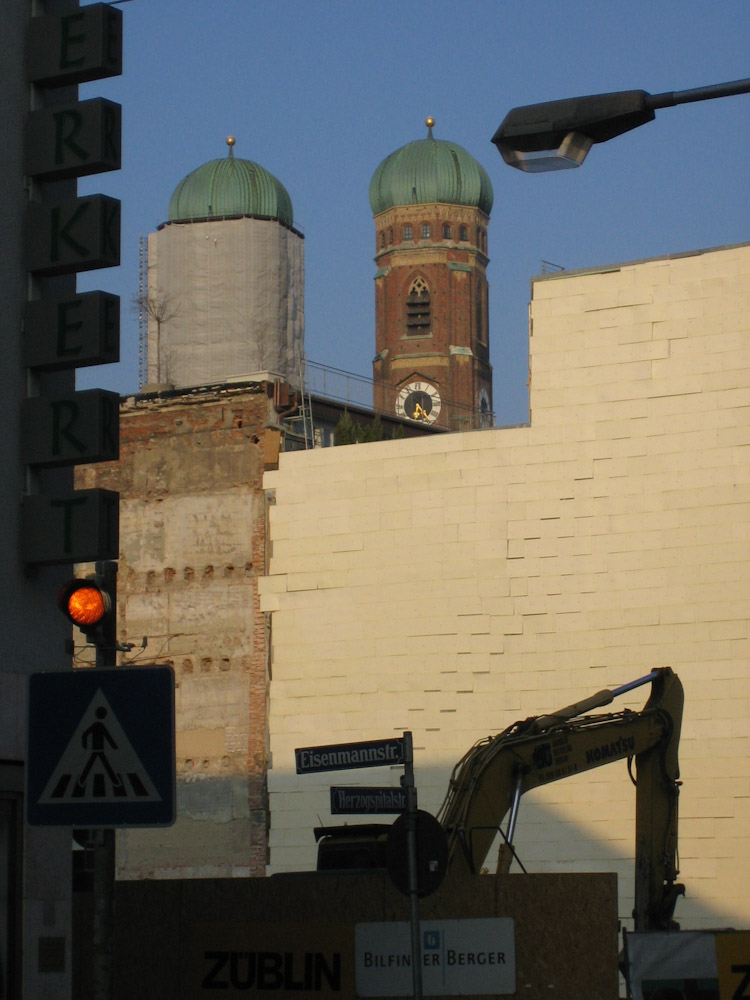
xmin=168 ymin=136 xmax=293 ymax=226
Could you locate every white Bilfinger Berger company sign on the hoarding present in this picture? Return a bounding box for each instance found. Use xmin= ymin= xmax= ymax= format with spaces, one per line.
xmin=355 ymin=917 xmax=516 ymax=997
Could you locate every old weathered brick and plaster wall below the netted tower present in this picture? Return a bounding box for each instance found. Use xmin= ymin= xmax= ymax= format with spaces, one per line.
xmin=79 ymin=386 xmax=278 ymax=878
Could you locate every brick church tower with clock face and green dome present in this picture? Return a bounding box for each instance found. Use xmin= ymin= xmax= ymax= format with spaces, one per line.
xmin=370 ymin=118 xmax=493 ymax=431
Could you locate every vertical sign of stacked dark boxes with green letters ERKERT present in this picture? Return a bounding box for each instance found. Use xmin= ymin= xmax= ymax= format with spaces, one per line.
xmin=21 ymin=3 xmax=122 ymax=563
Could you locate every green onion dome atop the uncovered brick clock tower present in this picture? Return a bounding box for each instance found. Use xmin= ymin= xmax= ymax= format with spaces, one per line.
xmin=370 ymin=118 xmax=493 ymax=215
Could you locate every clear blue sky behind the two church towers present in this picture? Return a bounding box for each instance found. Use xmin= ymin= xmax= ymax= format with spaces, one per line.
xmin=78 ymin=0 xmax=750 ymax=425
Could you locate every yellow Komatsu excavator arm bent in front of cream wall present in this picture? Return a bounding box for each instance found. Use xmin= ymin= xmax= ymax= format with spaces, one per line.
xmin=438 ymin=667 xmax=684 ymax=930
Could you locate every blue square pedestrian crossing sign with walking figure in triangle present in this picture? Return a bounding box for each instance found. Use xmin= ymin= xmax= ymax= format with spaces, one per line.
xmin=26 ymin=667 xmax=175 ymax=827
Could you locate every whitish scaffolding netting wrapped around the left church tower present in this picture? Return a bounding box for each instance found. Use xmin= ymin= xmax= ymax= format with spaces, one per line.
xmin=146 ymin=218 xmax=304 ymax=388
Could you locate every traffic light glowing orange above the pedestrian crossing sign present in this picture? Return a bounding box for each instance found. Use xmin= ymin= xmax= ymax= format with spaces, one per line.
xmin=57 ymin=563 xmax=117 ymax=666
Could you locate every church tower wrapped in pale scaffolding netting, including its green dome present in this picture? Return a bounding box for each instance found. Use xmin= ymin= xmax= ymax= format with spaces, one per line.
xmin=141 ymin=136 xmax=305 ymax=388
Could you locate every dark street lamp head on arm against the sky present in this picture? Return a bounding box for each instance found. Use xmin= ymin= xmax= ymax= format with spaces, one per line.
xmin=492 ymin=80 xmax=750 ymax=173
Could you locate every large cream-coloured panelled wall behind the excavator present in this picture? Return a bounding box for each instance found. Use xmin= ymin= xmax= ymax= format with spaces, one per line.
xmin=261 ymin=245 xmax=750 ymax=927
